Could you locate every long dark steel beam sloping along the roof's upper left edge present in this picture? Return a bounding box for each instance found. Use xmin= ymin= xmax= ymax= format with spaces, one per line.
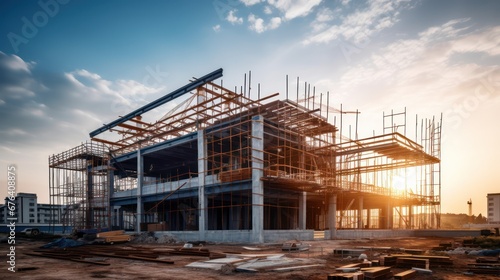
xmin=89 ymin=68 xmax=222 ymax=138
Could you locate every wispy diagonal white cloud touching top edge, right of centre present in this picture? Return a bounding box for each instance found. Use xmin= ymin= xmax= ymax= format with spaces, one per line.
xmin=303 ymin=0 xmax=410 ymax=44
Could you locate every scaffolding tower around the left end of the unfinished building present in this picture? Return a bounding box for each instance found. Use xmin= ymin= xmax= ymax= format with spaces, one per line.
xmin=49 ymin=142 xmax=111 ymax=232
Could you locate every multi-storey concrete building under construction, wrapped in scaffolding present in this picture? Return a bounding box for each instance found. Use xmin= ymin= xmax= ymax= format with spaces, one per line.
xmin=49 ymin=69 xmax=441 ymax=242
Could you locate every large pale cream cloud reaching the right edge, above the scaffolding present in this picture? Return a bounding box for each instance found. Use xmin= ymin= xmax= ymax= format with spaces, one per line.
xmin=332 ymin=20 xmax=500 ymax=111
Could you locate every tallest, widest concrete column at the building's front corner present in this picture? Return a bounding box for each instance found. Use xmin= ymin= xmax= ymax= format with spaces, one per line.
xmin=251 ymin=116 xmax=264 ymax=243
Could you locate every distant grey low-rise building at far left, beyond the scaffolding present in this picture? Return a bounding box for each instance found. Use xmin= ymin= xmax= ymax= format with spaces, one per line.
xmin=0 ymin=193 xmax=63 ymax=224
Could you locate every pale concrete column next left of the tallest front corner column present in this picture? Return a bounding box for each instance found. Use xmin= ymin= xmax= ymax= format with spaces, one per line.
xmin=198 ymin=130 xmax=207 ymax=241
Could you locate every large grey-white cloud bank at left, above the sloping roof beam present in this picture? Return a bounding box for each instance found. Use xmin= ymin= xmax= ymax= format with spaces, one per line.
xmin=0 ymin=54 xmax=165 ymax=153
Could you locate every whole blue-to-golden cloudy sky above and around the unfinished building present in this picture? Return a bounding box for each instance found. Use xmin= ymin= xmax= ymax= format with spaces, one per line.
xmin=0 ymin=0 xmax=500 ymax=215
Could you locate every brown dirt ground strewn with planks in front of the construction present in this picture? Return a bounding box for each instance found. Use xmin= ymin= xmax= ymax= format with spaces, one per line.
xmin=0 ymin=237 xmax=500 ymax=280
